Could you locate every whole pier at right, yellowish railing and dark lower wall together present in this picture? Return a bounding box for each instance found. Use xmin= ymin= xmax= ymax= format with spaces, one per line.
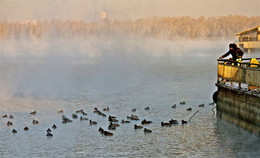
xmin=213 ymin=58 xmax=260 ymax=136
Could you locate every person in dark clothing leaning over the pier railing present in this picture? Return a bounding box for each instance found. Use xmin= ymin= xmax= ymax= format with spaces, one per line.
xmin=219 ymin=43 xmax=244 ymax=65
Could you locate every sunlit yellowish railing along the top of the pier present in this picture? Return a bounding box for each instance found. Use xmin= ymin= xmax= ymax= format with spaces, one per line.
xmin=217 ymin=58 xmax=260 ymax=90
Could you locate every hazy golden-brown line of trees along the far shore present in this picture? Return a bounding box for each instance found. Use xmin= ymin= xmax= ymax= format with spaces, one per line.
xmin=0 ymin=15 xmax=260 ymax=40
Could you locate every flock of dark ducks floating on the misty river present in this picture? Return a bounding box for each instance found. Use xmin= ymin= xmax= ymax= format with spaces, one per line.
xmin=2 ymin=101 xmax=214 ymax=137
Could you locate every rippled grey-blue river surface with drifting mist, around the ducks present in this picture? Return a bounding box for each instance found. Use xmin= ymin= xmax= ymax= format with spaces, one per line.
xmin=0 ymin=39 xmax=260 ymax=158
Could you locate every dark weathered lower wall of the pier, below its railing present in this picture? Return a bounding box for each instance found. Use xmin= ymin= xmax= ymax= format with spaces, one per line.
xmin=217 ymin=85 xmax=260 ymax=136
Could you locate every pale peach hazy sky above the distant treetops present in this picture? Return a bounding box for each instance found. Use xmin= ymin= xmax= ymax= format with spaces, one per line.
xmin=0 ymin=0 xmax=260 ymax=21
